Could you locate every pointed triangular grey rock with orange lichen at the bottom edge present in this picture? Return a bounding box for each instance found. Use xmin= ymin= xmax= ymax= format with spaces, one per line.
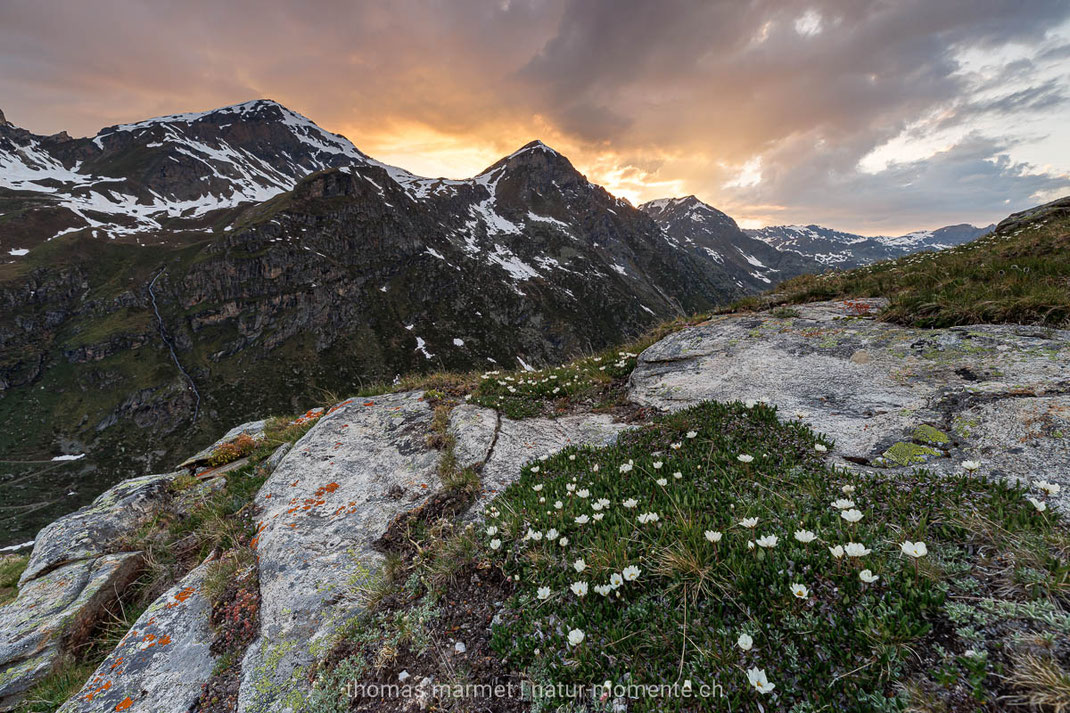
xmin=60 ymin=563 xmax=215 ymax=713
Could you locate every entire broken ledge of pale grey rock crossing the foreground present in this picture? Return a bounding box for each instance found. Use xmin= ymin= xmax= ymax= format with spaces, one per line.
xmin=0 ymin=301 xmax=1070 ymax=713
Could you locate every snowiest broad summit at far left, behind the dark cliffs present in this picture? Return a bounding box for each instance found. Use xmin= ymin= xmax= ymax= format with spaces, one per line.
xmin=0 ymin=100 xmax=415 ymax=247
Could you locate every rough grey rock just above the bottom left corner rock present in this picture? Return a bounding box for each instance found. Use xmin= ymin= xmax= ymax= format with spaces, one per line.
xmin=19 ymin=473 xmax=177 ymax=582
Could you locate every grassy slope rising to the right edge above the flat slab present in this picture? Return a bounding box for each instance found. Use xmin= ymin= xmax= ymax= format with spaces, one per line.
xmin=732 ymin=205 xmax=1070 ymax=328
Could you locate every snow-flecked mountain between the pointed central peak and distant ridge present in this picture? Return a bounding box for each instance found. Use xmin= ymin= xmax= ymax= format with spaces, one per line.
xmin=639 ymin=196 xmax=822 ymax=291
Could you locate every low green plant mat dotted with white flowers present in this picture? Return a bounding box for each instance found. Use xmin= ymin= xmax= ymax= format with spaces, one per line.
xmin=483 ymin=403 xmax=1070 ymax=711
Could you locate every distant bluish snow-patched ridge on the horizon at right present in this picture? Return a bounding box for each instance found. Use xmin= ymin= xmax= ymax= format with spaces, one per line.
xmin=746 ymin=224 xmax=995 ymax=268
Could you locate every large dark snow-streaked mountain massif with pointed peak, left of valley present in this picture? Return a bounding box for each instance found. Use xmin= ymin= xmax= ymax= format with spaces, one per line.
xmin=0 ymin=101 xmax=748 ymax=541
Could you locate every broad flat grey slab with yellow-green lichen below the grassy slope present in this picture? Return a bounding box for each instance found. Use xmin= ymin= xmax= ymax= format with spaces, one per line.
xmin=629 ymin=301 xmax=1070 ymax=489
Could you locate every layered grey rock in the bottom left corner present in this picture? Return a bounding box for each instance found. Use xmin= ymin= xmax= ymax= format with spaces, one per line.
xmin=0 ymin=552 xmax=141 ymax=711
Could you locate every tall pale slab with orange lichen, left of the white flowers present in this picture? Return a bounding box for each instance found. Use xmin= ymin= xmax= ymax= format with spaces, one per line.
xmin=239 ymin=392 xmax=470 ymax=713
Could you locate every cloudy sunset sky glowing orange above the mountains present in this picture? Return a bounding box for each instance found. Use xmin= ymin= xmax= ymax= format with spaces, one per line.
xmin=0 ymin=0 xmax=1070 ymax=234
